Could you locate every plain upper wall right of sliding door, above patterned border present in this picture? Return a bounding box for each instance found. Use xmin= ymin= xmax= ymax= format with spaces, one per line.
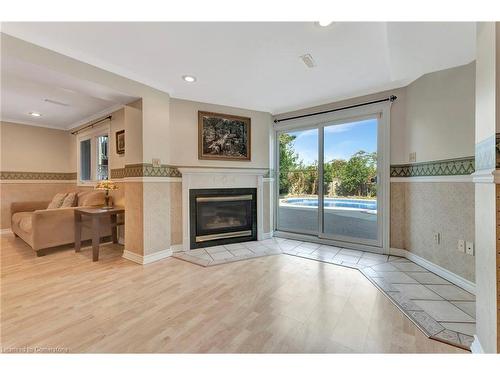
xmin=404 ymin=63 xmax=475 ymax=163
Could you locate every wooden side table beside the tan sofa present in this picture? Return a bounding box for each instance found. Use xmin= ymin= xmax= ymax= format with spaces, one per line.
xmin=75 ymin=207 xmax=125 ymax=262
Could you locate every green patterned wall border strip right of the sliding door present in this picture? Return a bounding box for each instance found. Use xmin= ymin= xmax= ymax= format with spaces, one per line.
xmin=391 ymin=156 xmax=475 ymax=177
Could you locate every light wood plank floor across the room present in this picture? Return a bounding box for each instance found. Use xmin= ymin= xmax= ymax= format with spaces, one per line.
xmin=1 ymin=235 xmax=466 ymax=353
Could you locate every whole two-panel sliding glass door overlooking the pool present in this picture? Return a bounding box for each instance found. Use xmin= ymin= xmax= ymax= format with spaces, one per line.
xmin=276 ymin=117 xmax=382 ymax=247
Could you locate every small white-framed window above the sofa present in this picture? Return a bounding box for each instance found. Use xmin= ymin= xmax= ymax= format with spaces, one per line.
xmin=77 ymin=126 xmax=109 ymax=184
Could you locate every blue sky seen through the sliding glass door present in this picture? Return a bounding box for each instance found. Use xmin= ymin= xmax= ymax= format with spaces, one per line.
xmin=289 ymin=119 xmax=377 ymax=164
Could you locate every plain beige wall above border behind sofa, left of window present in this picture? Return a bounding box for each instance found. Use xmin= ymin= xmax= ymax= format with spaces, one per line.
xmin=0 ymin=122 xmax=75 ymax=173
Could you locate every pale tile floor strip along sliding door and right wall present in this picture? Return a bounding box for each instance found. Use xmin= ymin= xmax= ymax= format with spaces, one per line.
xmin=277 ymin=238 xmax=476 ymax=350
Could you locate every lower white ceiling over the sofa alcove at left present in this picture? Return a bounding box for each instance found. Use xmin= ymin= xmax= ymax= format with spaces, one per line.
xmin=1 ymin=56 xmax=138 ymax=129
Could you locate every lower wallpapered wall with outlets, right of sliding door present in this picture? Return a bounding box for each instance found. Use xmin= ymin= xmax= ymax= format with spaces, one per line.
xmin=391 ymin=182 xmax=475 ymax=282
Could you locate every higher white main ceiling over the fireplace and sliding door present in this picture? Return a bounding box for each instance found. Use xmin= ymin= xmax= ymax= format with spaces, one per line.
xmin=2 ymin=22 xmax=475 ymax=116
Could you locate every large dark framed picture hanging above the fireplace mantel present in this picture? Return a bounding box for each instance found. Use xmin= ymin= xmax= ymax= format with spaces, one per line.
xmin=198 ymin=111 xmax=252 ymax=161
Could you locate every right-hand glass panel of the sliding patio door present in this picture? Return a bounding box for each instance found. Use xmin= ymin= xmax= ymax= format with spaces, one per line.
xmin=320 ymin=119 xmax=379 ymax=245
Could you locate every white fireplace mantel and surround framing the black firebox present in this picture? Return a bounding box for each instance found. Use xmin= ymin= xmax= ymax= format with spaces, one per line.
xmin=179 ymin=167 xmax=268 ymax=251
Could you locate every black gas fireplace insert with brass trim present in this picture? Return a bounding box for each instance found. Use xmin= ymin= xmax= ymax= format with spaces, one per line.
xmin=189 ymin=188 xmax=257 ymax=249
